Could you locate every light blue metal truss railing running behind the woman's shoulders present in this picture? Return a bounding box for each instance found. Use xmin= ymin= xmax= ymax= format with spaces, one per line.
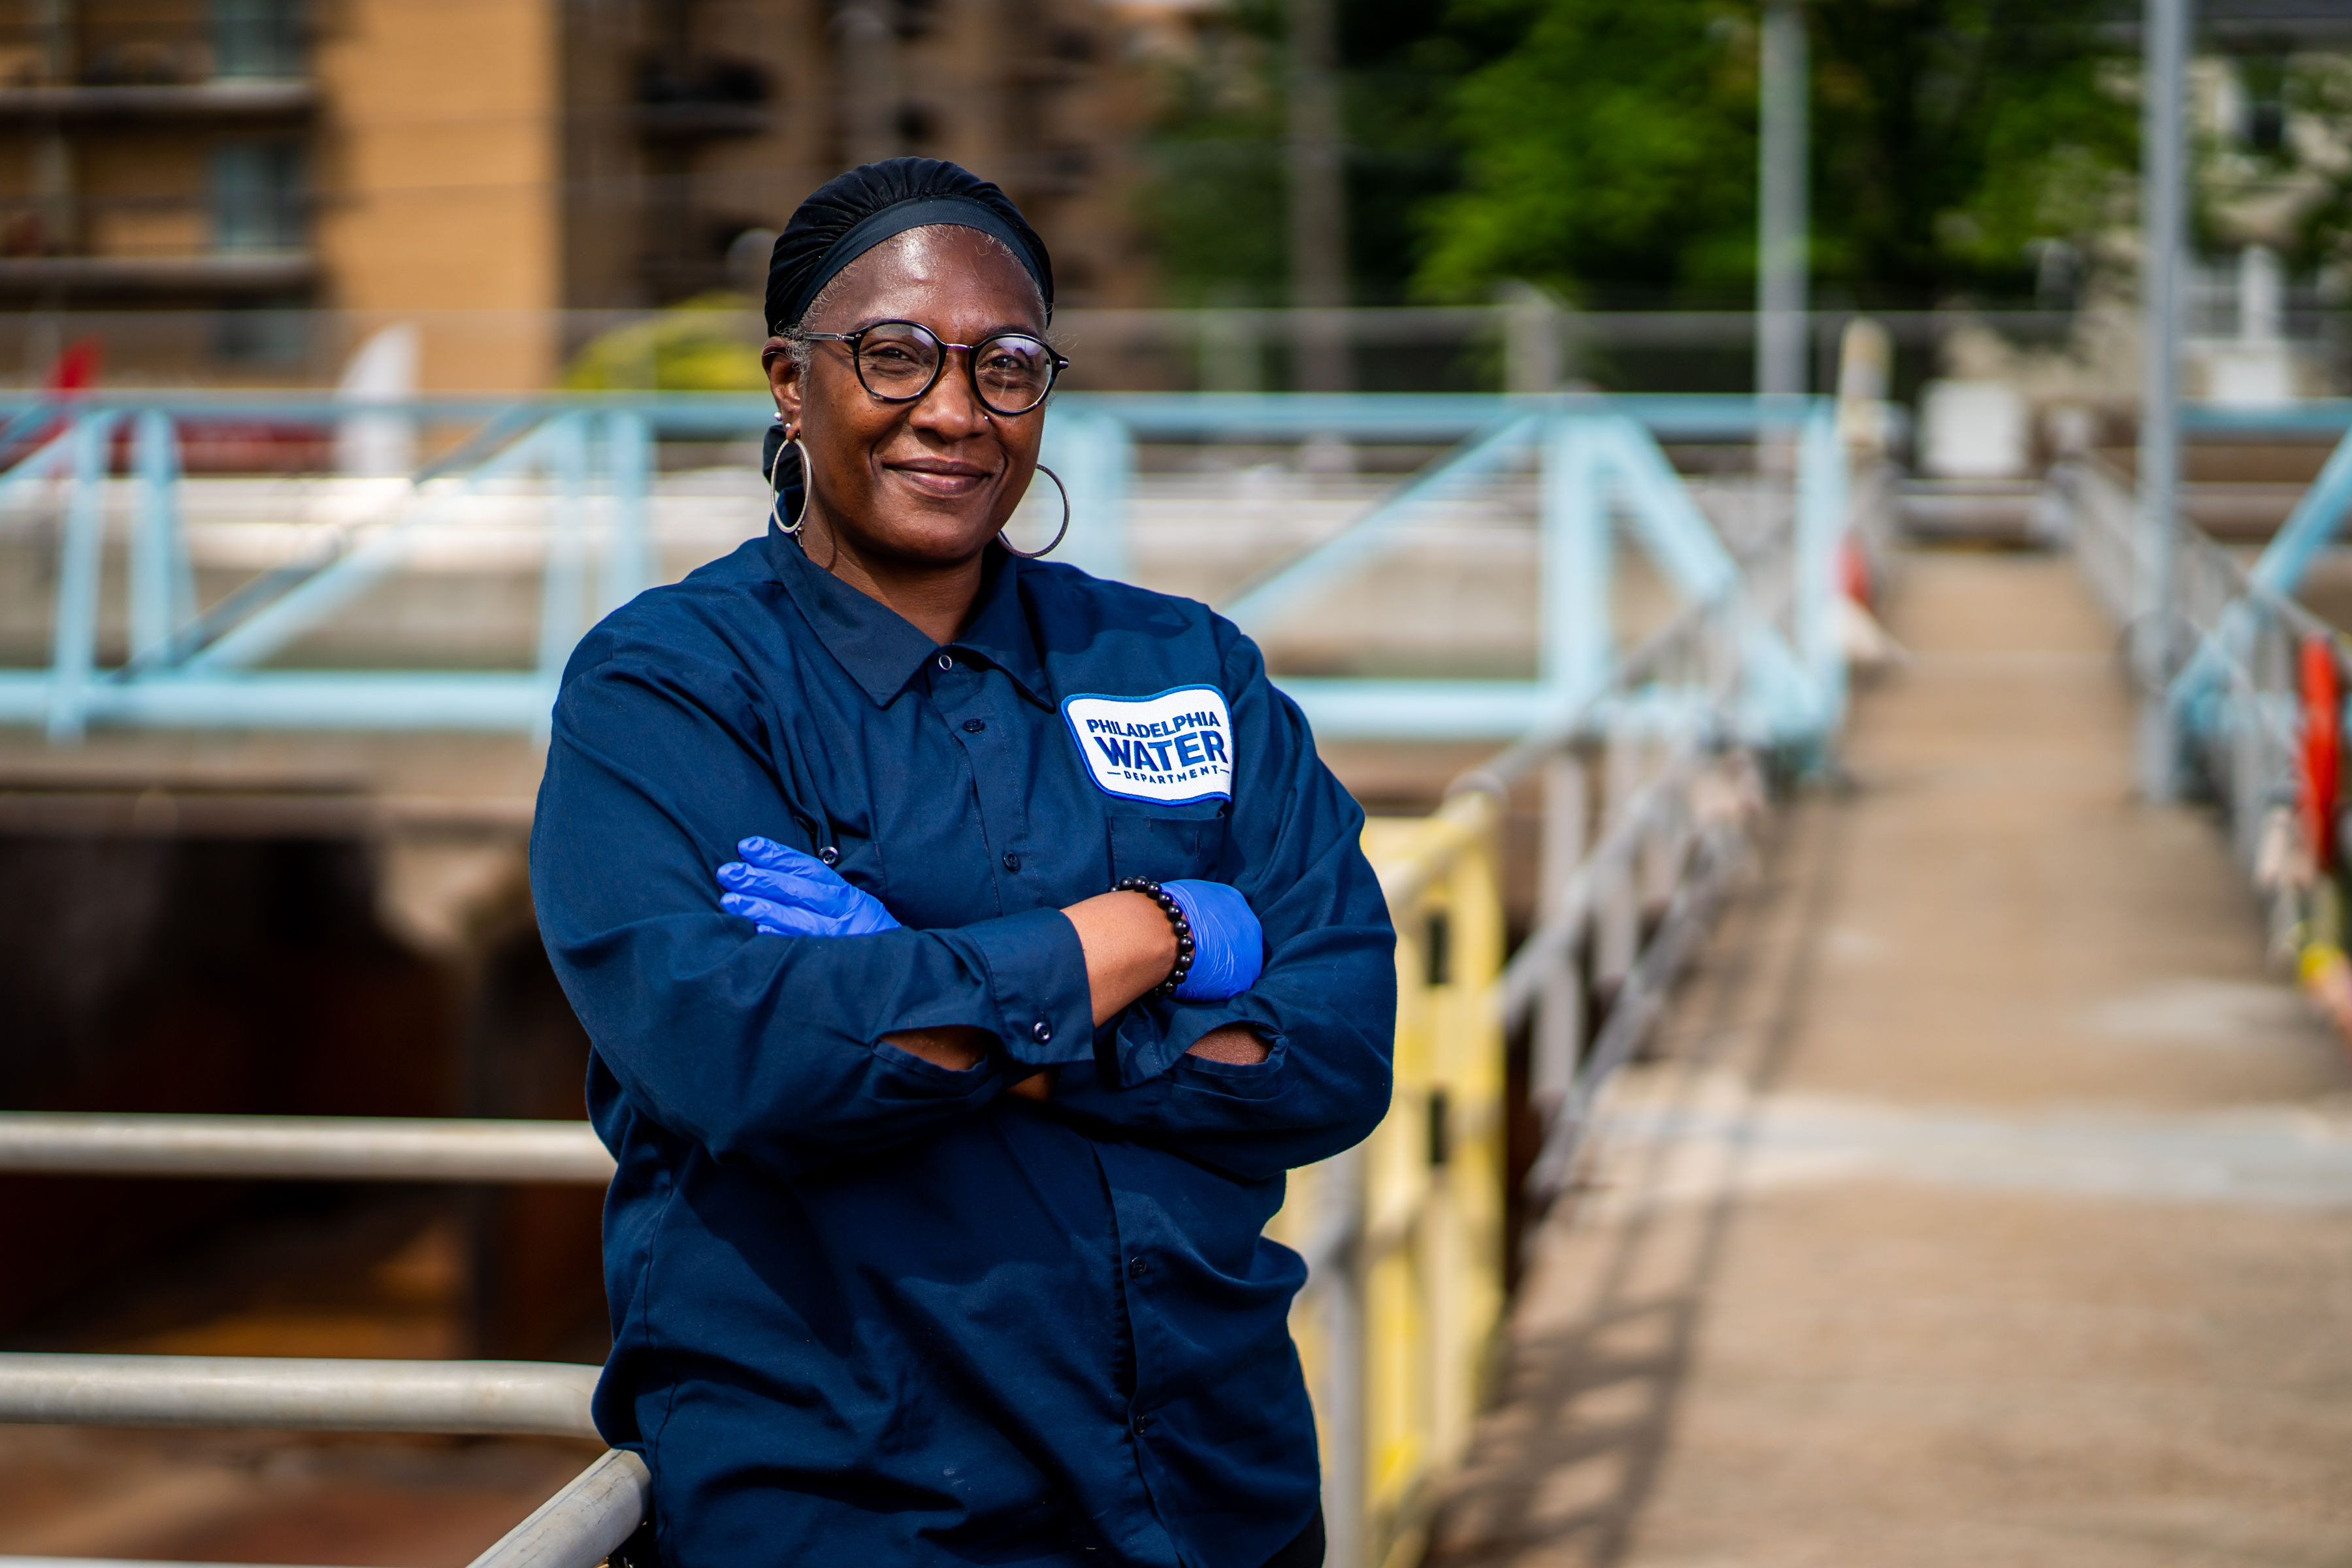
xmin=0 ymin=393 xmax=1849 ymax=743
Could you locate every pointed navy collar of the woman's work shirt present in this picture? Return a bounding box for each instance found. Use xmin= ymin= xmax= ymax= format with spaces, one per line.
xmin=767 ymin=522 xmax=1054 ymax=708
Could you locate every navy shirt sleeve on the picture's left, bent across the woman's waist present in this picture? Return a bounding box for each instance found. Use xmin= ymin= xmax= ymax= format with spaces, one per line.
xmin=532 ymin=630 xmax=1091 ymax=1171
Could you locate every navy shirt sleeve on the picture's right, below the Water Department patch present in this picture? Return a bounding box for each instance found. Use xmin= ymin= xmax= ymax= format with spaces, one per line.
xmin=1054 ymin=623 xmax=1397 ymax=1178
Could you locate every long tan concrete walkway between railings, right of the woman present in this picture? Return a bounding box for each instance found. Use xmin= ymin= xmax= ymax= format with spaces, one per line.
xmin=1432 ymin=555 xmax=2352 ymax=1568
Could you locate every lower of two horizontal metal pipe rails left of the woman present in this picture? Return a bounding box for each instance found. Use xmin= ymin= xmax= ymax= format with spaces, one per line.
xmin=0 ymin=1354 xmax=602 ymax=1439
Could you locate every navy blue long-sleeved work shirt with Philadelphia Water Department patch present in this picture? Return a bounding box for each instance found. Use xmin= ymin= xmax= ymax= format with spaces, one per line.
xmin=532 ymin=517 xmax=1395 ymax=1568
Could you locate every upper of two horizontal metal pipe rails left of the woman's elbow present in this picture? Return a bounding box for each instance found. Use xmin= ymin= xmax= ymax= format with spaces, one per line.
xmin=0 ymin=1112 xmax=612 ymax=1187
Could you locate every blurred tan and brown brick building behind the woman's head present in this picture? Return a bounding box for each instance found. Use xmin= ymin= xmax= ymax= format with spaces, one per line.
xmin=0 ymin=0 xmax=1148 ymax=388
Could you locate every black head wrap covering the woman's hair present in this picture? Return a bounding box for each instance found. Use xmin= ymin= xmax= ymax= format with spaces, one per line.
xmin=760 ymin=157 xmax=1054 ymax=517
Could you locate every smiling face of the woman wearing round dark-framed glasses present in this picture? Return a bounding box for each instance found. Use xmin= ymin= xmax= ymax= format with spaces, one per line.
xmin=769 ymin=225 xmax=1044 ymax=571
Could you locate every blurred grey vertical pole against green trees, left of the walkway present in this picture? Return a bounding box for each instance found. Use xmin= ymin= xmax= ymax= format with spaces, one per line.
xmin=1757 ymin=0 xmax=1811 ymax=397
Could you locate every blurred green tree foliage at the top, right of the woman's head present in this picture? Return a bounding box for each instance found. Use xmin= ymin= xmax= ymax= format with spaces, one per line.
xmin=1145 ymin=0 xmax=2138 ymax=306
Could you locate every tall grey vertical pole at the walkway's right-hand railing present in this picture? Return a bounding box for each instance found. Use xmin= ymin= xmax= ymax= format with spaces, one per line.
xmin=2138 ymin=0 xmax=2192 ymax=802
